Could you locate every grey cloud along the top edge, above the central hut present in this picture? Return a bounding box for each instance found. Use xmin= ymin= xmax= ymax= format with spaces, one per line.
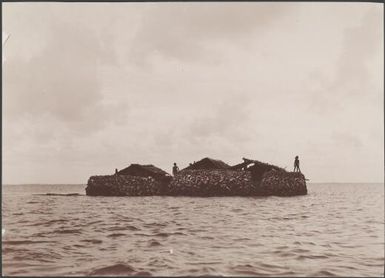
xmin=129 ymin=3 xmax=290 ymax=65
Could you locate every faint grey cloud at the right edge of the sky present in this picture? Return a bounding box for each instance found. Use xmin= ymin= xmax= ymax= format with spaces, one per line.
xmin=309 ymin=8 xmax=383 ymax=114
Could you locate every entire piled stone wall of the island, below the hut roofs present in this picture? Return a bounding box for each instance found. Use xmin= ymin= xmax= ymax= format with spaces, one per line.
xmin=86 ymin=169 xmax=307 ymax=197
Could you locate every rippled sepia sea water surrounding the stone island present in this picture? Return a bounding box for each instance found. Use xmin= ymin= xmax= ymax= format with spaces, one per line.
xmin=2 ymin=183 xmax=384 ymax=276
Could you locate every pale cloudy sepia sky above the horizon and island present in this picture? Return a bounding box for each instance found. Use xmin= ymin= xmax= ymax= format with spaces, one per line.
xmin=2 ymin=2 xmax=384 ymax=184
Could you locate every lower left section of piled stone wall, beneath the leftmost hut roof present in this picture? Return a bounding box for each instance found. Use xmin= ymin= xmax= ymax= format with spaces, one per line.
xmin=86 ymin=175 xmax=166 ymax=196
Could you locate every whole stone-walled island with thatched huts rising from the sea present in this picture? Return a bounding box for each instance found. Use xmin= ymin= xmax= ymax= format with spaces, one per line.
xmin=86 ymin=157 xmax=307 ymax=197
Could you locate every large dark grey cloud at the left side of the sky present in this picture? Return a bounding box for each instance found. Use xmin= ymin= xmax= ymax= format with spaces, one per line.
xmin=4 ymin=14 xmax=128 ymax=138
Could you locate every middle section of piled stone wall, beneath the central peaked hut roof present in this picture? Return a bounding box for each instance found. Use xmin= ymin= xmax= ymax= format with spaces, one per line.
xmin=167 ymin=170 xmax=256 ymax=197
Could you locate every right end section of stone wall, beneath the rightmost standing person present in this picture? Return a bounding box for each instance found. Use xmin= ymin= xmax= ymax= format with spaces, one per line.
xmin=258 ymin=170 xmax=307 ymax=196
